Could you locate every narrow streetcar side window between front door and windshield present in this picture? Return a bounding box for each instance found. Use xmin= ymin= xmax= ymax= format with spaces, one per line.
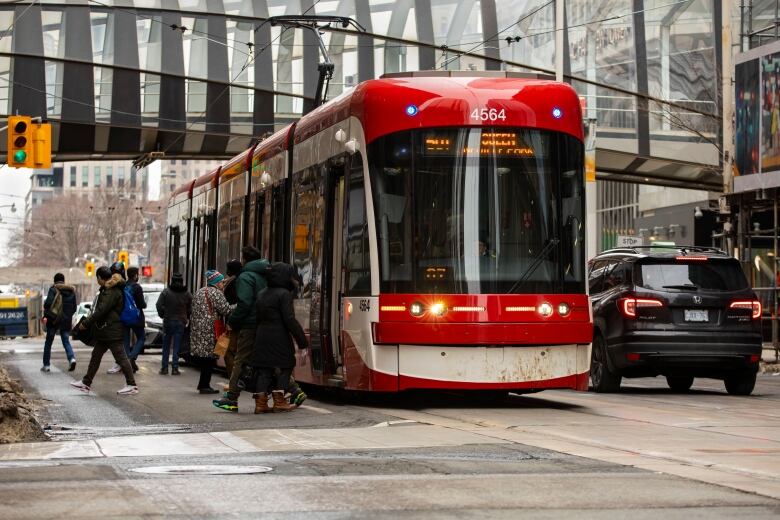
xmin=344 ymin=153 xmax=371 ymax=296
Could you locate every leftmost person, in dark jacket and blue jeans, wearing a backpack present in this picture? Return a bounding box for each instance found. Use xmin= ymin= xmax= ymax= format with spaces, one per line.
xmin=41 ymin=273 xmax=76 ymax=372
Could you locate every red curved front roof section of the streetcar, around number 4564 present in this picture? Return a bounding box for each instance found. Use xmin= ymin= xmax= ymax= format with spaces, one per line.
xmin=295 ymin=73 xmax=583 ymax=143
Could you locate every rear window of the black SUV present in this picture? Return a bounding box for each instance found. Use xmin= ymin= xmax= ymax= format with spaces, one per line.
xmin=637 ymin=260 xmax=749 ymax=291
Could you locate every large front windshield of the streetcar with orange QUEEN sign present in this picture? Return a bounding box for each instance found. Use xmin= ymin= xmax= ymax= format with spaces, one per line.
xmin=368 ymin=127 xmax=585 ymax=294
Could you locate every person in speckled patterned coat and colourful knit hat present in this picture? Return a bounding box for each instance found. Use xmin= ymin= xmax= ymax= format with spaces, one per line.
xmin=190 ymin=270 xmax=231 ymax=394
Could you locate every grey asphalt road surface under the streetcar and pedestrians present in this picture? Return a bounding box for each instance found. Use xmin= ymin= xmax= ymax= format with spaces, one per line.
xmin=0 ymin=341 xmax=780 ymax=520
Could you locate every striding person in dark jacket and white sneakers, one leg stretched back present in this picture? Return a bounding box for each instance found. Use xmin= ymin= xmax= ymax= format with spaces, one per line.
xmin=70 ymin=266 xmax=138 ymax=395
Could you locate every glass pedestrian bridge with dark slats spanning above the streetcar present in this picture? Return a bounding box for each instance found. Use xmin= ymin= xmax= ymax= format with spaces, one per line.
xmin=0 ymin=0 xmax=728 ymax=190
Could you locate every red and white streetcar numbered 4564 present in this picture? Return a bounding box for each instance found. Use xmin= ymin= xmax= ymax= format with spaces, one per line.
xmin=168 ymin=73 xmax=592 ymax=392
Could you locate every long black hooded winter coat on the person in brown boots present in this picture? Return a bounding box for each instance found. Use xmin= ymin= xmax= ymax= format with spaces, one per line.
xmin=249 ymin=264 xmax=309 ymax=368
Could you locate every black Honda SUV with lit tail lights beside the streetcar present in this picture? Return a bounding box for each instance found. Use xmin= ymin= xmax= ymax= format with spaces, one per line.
xmin=588 ymin=246 xmax=761 ymax=395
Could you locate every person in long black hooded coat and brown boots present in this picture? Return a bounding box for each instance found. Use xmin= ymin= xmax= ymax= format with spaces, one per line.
xmin=244 ymin=263 xmax=309 ymax=413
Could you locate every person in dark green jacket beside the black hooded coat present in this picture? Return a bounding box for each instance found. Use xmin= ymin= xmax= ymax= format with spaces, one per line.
xmin=212 ymin=246 xmax=270 ymax=412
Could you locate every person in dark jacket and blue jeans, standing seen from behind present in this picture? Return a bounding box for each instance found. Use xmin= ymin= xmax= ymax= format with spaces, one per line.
xmin=157 ymin=273 xmax=192 ymax=376
